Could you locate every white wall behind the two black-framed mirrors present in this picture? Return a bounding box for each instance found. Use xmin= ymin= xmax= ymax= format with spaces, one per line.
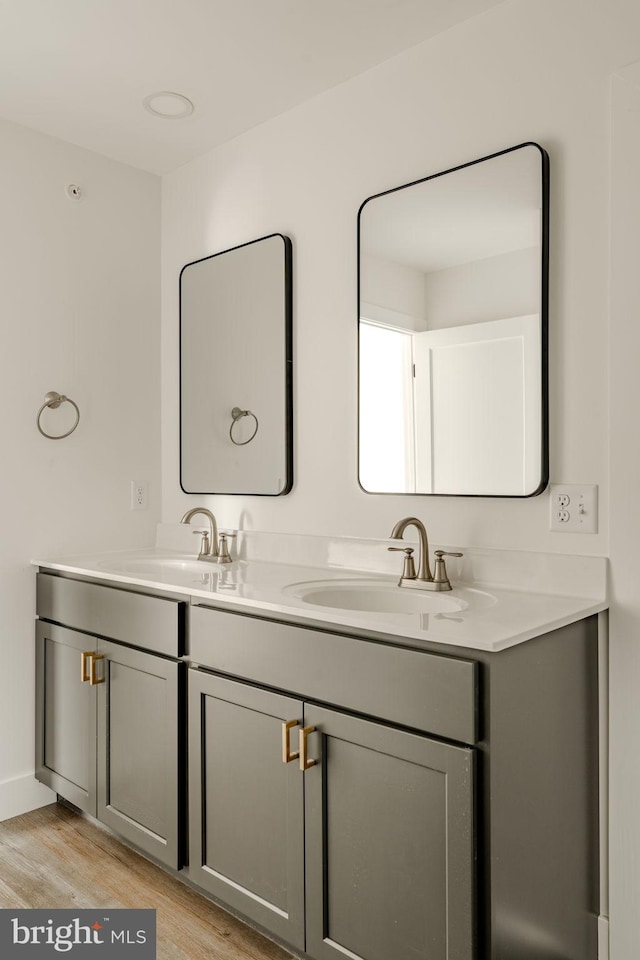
xmin=162 ymin=0 xmax=640 ymax=554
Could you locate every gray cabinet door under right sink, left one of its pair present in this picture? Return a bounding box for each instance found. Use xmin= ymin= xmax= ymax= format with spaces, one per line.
xmin=189 ymin=670 xmax=304 ymax=949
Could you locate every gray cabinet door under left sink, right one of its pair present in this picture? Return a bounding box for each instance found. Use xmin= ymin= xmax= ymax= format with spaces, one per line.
xmin=95 ymin=640 xmax=184 ymax=869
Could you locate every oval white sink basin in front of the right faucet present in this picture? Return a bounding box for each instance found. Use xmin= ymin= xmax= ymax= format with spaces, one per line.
xmin=283 ymin=580 xmax=497 ymax=614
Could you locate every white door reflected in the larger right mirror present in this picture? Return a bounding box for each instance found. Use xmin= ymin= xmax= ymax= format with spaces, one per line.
xmin=413 ymin=314 xmax=540 ymax=496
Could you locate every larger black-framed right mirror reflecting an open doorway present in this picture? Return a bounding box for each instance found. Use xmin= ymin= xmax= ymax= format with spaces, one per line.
xmin=358 ymin=143 xmax=549 ymax=497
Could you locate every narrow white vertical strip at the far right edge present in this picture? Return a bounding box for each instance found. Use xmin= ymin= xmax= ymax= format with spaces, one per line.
xmin=610 ymin=64 xmax=640 ymax=960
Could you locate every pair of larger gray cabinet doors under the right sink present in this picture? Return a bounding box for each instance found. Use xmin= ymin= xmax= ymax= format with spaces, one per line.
xmin=189 ymin=670 xmax=475 ymax=960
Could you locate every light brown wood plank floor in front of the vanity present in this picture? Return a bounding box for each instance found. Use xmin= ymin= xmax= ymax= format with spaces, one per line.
xmin=0 ymin=804 xmax=291 ymax=960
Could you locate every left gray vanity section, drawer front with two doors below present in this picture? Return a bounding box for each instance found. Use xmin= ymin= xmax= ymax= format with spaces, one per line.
xmin=36 ymin=573 xmax=186 ymax=869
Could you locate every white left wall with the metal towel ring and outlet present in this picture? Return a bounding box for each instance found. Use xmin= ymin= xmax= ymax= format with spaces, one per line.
xmin=0 ymin=123 xmax=160 ymax=820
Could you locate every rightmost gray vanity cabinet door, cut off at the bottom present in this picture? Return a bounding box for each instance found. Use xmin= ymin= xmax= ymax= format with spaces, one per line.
xmin=305 ymin=704 xmax=474 ymax=960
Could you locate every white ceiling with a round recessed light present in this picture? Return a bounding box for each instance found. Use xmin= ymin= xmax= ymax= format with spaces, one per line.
xmin=0 ymin=0 xmax=504 ymax=173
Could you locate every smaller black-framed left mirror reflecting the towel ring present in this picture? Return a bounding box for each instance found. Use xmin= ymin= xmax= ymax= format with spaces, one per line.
xmin=180 ymin=233 xmax=293 ymax=496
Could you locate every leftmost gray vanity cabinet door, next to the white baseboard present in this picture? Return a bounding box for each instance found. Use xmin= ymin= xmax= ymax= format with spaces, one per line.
xmin=35 ymin=620 xmax=96 ymax=816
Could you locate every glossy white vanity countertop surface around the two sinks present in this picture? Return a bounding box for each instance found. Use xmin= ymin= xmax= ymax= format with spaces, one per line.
xmin=31 ymin=552 xmax=608 ymax=652
